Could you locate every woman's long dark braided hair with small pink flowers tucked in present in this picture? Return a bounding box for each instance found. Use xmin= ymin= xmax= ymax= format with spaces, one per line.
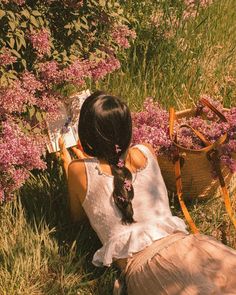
xmin=79 ymin=91 xmax=134 ymax=224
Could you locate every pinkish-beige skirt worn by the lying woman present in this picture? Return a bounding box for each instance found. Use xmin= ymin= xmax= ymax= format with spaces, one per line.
xmin=125 ymin=233 xmax=236 ymax=295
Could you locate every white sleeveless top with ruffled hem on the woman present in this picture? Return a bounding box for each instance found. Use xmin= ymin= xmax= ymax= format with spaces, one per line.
xmin=83 ymin=145 xmax=187 ymax=266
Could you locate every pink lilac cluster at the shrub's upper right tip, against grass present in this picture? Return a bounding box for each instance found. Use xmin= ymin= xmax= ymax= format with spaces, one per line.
xmin=111 ymin=25 xmax=136 ymax=48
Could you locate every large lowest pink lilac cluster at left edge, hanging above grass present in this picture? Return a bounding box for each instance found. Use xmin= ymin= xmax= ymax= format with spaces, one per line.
xmin=0 ymin=119 xmax=46 ymax=202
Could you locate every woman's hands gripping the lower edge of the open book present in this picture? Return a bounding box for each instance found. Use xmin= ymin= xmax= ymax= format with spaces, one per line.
xmin=57 ymin=137 xmax=87 ymax=178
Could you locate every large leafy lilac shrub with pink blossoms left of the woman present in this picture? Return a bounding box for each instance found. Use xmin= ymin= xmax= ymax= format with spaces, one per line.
xmin=0 ymin=0 xmax=135 ymax=200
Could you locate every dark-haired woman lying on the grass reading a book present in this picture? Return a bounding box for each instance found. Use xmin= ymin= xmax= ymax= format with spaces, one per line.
xmin=60 ymin=92 xmax=236 ymax=295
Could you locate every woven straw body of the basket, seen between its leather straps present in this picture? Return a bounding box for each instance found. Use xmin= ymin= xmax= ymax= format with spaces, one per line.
xmin=158 ymin=109 xmax=236 ymax=198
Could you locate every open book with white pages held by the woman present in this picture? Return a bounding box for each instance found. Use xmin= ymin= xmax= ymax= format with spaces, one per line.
xmin=47 ymin=89 xmax=91 ymax=153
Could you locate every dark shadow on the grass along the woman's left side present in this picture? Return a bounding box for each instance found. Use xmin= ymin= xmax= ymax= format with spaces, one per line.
xmin=19 ymin=156 xmax=118 ymax=295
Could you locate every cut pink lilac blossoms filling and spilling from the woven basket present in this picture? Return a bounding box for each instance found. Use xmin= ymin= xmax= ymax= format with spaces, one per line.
xmin=133 ymin=95 xmax=236 ymax=172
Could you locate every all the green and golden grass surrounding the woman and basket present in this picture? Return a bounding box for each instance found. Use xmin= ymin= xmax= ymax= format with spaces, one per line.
xmin=0 ymin=0 xmax=236 ymax=295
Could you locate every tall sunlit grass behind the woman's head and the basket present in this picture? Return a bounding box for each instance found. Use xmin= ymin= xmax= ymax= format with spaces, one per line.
xmin=100 ymin=0 xmax=236 ymax=109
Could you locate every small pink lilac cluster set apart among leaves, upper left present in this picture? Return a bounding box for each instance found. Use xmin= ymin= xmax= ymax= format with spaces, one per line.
xmin=29 ymin=29 xmax=51 ymax=57
